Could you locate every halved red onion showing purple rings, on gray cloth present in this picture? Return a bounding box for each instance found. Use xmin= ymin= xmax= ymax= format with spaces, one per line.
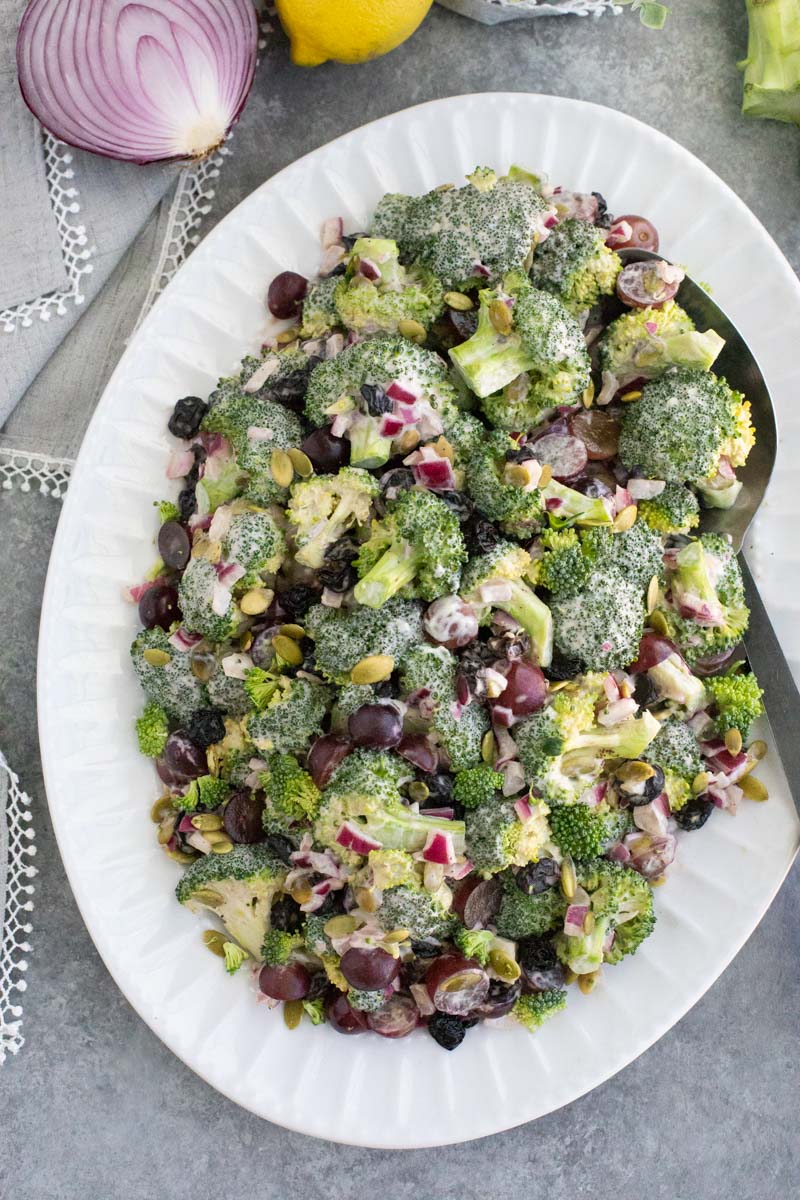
xmin=17 ymin=0 xmax=258 ymax=163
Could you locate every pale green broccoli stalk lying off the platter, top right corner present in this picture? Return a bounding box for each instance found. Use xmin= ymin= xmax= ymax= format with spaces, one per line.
xmin=739 ymin=0 xmax=800 ymax=125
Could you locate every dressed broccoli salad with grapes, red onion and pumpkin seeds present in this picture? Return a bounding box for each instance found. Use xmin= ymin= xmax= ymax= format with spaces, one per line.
xmin=131 ymin=167 xmax=766 ymax=1050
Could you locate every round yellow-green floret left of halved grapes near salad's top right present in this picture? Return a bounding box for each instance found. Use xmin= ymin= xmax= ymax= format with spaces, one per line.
xmin=530 ymin=217 xmax=622 ymax=314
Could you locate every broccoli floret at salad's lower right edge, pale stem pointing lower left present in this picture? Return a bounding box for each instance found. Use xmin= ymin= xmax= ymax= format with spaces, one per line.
xmin=555 ymin=858 xmax=656 ymax=974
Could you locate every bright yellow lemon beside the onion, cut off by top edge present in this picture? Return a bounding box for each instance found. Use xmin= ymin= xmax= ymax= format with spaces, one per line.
xmin=277 ymin=0 xmax=433 ymax=67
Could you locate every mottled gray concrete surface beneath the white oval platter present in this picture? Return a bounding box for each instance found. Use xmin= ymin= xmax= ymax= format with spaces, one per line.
xmin=0 ymin=0 xmax=800 ymax=1200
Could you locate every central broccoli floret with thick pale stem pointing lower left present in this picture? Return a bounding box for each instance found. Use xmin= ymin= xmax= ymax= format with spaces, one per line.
xmin=354 ymin=488 xmax=467 ymax=608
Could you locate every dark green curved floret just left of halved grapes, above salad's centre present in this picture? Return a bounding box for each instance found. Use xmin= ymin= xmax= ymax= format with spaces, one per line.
xmin=467 ymin=430 xmax=545 ymax=539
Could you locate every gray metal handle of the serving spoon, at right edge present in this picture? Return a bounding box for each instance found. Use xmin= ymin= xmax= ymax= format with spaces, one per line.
xmin=739 ymin=554 xmax=800 ymax=811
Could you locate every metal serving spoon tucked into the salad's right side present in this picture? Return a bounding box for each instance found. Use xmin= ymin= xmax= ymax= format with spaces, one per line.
xmin=620 ymin=250 xmax=800 ymax=811
